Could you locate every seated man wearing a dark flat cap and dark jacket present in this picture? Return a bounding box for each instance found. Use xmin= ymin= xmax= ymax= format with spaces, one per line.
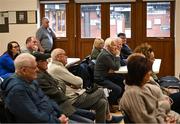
xmin=33 ymin=52 xmax=95 ymax=123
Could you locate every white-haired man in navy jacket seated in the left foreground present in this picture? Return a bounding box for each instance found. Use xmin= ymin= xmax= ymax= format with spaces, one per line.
xmin=1 ymin=53 xmax=68 ymax=123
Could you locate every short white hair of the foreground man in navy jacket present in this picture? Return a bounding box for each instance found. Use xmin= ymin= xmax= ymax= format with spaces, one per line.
xmin=14 ymin=53 xmax=36 ymax=70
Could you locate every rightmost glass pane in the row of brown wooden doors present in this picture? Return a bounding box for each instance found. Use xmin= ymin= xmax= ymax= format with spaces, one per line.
xmin=146 ymin=2 xmax=170 ymax=37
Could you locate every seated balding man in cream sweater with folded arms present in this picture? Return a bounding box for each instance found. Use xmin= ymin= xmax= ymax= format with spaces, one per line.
xmin=48 ymin=48 xmax=122 ymax=123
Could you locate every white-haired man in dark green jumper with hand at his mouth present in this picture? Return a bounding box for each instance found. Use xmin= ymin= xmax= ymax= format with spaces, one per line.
xmin=94 ymin=38 xmax=123 ymax=105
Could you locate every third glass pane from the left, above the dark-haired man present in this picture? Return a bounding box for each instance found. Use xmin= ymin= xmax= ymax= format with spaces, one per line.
xmin=110 ymin=4 xmax=131 ymax=38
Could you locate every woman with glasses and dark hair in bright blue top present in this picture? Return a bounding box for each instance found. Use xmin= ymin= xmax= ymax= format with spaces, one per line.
xmin=0 ymin=41 xmax=21 ymax=79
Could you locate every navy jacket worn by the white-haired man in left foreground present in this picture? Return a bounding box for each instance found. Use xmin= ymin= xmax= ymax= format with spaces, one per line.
xmin=1 ymin=74 xmax=60 ymax=123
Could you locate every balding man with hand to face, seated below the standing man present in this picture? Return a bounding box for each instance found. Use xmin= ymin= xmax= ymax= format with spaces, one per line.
xmin=22 ymin=36 xmax=44 ymax=53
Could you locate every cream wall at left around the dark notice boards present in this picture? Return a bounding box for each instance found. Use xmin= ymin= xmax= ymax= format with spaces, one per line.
xmin=0 ymin=0 xmax=38 ymax=54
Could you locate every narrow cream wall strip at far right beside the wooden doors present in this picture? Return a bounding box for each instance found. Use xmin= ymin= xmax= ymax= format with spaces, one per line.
xmin=175 ymin=0 xmax=180 ymax=77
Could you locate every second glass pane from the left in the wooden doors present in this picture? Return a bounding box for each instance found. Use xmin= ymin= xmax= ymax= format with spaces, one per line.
xmin=81 ymin=4 xmax=101 ymax=38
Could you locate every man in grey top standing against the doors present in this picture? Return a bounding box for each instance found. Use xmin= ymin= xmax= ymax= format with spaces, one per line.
xmin=36 ymin=17 xmax=56 ymax=52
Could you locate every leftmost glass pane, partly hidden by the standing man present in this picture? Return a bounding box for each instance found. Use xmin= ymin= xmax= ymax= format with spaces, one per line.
xmin=45 ymin=4 xmax=66 ymax=37
